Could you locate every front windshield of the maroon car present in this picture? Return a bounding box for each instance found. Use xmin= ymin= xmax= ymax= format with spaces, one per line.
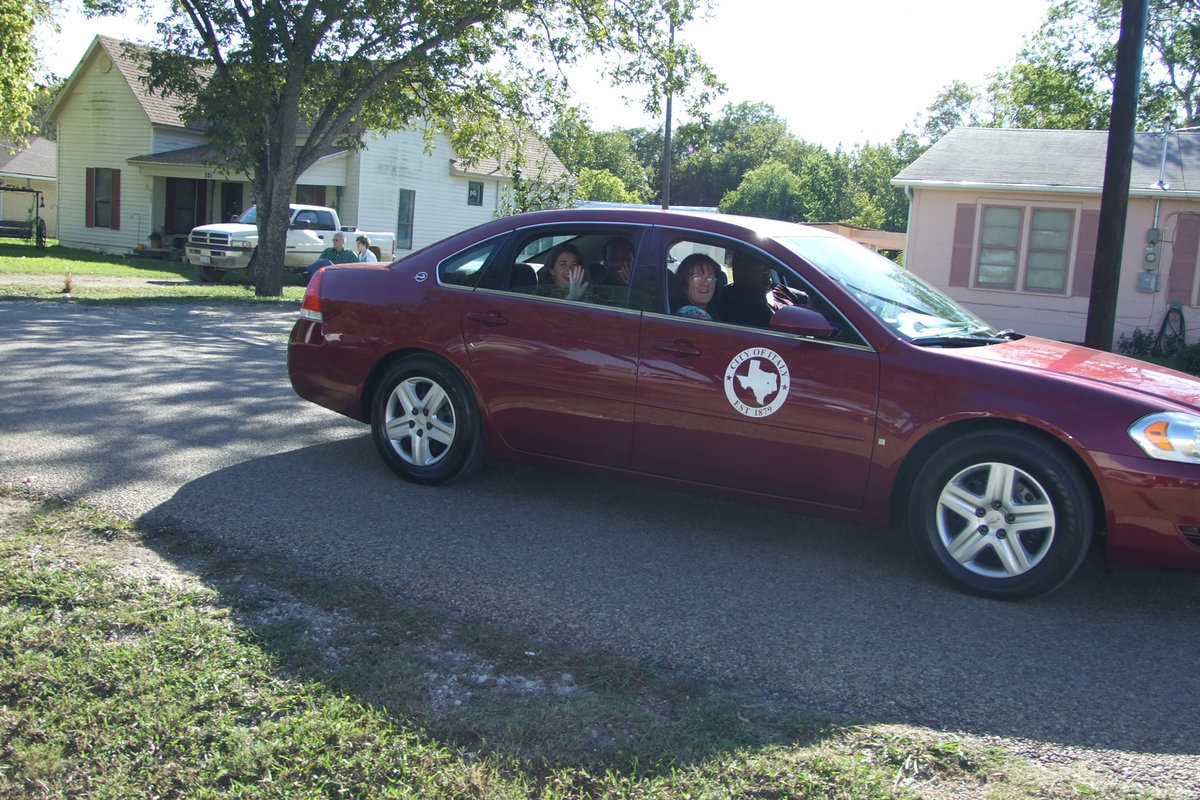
xmin=779 ymin=236 xmax=998 ymax=341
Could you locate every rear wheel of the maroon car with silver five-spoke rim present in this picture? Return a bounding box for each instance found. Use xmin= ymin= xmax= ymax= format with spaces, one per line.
xmin=371 ymin=355 xmax=484 ymax=485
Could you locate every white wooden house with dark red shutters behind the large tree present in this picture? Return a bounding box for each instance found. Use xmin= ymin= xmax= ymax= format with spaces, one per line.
xmin=48 ymin=36 xmax=566 ymax=254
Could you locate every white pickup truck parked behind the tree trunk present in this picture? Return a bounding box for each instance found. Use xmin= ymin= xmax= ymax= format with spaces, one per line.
xmin=187 ymin=204 xmax=396 ymax=281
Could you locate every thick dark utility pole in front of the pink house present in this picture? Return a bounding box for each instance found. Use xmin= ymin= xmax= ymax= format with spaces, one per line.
xmin=1084 ymin=0 xmax=1148 ymax=350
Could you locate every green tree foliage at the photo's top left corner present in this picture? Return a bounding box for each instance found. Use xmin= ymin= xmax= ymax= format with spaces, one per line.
xmin=0 ymin=0 xmax=50 ymax=148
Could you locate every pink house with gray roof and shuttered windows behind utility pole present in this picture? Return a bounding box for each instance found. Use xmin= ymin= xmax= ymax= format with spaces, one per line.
xmin=892 ymin=128 xmax=1200 ymax=343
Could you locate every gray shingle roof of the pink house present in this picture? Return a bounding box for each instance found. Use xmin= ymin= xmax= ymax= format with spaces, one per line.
xmin=892 ymin=128 xmax=1200 ymax=196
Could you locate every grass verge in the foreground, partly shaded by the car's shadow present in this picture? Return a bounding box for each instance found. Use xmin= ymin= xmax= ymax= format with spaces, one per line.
xmin=0 ymin=487 xmax=1180 ymax=800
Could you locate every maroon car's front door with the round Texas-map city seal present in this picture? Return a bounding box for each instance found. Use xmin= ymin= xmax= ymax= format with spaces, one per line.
xmin=631 ymin=234 xmax=880 ymax=507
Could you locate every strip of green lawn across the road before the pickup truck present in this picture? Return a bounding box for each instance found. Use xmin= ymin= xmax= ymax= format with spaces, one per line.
xmin=0 ymin=239 xmax=305 ymax=303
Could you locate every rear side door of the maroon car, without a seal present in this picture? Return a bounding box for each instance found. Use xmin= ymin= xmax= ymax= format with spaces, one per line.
xmin=462 ymin=225 xmax=641 ymax=467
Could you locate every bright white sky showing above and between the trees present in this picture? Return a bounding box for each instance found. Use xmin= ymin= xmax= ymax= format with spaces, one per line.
xmin=43 ymin=0 xmax=1048 ymax=149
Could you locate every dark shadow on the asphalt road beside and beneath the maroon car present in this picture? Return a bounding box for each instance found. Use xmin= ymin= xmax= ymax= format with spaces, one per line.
xmin=143 ymin=433 xmax=1200 ymax=754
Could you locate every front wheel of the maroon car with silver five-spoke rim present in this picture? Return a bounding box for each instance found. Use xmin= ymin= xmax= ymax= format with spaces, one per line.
xmin=908 ymin=431 xmax=1093 ymax=600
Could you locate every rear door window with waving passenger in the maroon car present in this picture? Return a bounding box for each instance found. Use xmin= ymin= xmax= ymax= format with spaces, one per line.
xmin=498 ymin=225 xmax=643 ymax=308
